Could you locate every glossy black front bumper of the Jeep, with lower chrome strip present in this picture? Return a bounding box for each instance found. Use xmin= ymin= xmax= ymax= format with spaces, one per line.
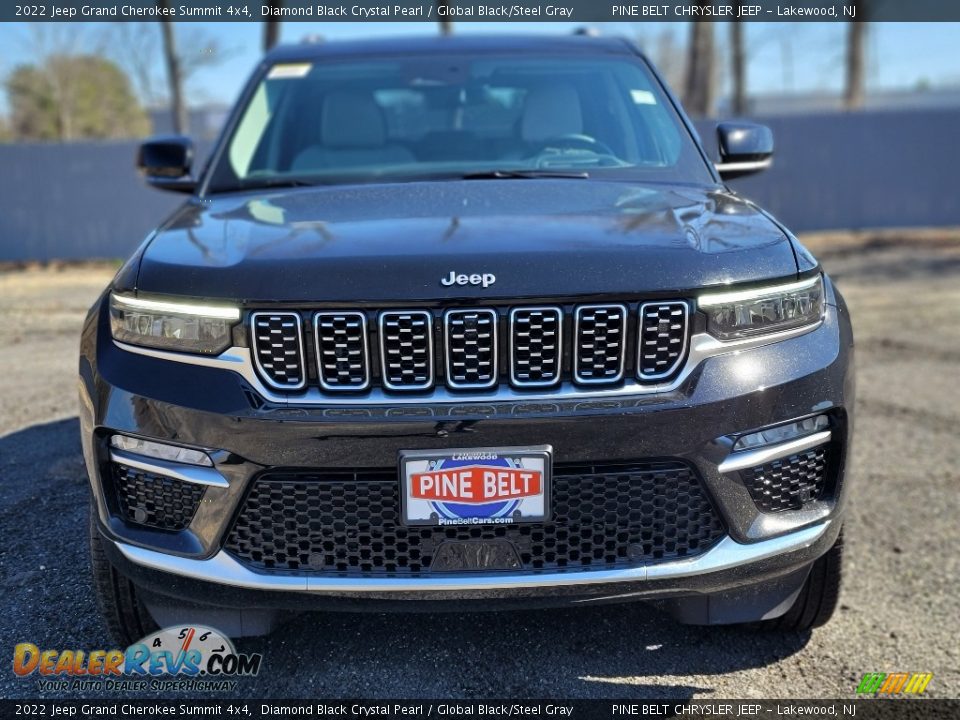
xmin=80 ymin=284 xmax=854 ymax=607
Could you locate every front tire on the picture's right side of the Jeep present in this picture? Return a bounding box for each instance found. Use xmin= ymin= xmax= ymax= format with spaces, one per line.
xmin=757 ymin=530 xmax=843 ymax=632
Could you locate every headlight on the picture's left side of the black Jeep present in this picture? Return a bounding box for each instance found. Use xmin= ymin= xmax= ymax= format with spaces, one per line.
xmin=110 ymin=293 xmax=240 ymax=353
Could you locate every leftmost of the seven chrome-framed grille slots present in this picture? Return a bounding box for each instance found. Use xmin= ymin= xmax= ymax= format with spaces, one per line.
xmin=250 ymin=313 xmax=307 ymax=390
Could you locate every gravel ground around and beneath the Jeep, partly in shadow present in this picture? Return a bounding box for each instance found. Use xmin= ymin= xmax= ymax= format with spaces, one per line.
xmin=0 ymin=238 xmax=960 ymax=699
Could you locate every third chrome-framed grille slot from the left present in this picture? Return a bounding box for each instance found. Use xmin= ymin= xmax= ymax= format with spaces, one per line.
xmin=380 ymin=310 xmax=434 ymax=390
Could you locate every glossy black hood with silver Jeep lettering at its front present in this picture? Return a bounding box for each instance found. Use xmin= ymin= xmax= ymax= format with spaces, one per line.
xmin=137 ymin=179 xmax=797 ymax=302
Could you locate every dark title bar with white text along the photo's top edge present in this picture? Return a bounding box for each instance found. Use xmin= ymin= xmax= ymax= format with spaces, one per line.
xmin=7 ymin=0 xmax=960 ymax=23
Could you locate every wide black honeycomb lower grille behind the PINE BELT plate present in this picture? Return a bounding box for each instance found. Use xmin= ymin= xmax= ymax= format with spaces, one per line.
xmin=225 ymin=461 xmax=725 ymax=576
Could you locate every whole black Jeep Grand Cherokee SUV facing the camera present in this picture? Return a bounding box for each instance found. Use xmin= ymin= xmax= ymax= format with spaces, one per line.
xmin=80 ymin=37 xmax=853 ymax=639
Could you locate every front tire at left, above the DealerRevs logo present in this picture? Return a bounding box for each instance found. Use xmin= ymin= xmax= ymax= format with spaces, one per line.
xmin=89 ymin=505 xmax=159 ymax=648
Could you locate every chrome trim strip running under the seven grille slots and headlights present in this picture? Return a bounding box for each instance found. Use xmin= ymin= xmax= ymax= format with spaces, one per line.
xmin=113 ymin=320 xmax=823 ymax=407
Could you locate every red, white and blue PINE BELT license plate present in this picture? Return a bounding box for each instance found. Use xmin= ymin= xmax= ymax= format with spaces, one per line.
xmin=400 ymin=445 xmax=553 ymax=525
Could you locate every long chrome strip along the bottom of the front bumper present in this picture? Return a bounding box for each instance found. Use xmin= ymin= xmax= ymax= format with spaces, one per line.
xmin=113 ymin=520 xmax=831 ymax=593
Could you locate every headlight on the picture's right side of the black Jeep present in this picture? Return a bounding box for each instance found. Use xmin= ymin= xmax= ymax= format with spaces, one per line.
xmin=698 ymin=275 xmax=823 ymax=340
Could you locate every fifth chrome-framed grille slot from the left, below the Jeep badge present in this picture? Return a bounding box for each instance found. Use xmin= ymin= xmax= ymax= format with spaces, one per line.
xmin=510 ymin=307 xmax=563 ymax=387
